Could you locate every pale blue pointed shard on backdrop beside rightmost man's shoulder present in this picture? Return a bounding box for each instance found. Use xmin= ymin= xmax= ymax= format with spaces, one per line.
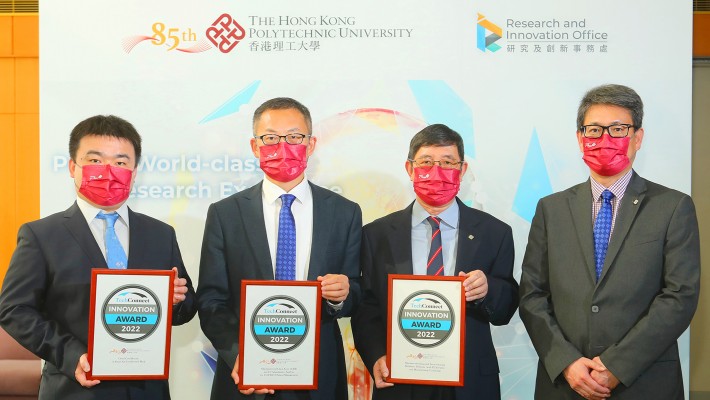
xmin=513 ymin=129 xmax=552 ymax=222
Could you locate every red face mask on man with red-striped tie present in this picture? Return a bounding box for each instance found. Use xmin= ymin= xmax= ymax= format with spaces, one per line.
xmin=412 ymin=165 xmax=461 ymax=207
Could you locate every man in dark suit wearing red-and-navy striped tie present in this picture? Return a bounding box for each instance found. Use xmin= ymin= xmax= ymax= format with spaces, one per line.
xmin=352 ymin=124 xmax=518 ymax=400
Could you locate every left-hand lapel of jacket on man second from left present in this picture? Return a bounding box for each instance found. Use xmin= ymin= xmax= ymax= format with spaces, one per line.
xmin=235 ymin=183 xmax=274 ymax=280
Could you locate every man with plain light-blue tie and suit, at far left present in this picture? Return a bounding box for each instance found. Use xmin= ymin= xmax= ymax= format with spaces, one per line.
xmin=0 ymin=115 xmax=196 ymax=400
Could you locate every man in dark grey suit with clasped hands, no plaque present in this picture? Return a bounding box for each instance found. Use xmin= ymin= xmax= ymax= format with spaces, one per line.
xmin=520 ymin=85 xmax=700 ymax=400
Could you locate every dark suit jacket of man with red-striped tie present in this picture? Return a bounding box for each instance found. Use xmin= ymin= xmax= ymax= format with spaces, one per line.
xmin=351 ymin=199 xmax=518 ymax=400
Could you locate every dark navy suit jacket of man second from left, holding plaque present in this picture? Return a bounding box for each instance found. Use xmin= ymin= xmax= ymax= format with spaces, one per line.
xmin=197 ymin=183 xmax=362 ymax=400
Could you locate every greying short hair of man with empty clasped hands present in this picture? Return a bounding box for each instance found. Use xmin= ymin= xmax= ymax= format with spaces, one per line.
xmin=577 ymin=84 xmax=643 ymax=131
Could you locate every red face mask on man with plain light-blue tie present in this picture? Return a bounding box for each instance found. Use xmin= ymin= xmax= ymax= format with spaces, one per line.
xmin=79 ymin=164 xmax=133 ymax=207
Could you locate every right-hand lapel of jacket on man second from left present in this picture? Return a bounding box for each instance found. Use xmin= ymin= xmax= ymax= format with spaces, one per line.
xmin=308 ymin=182 xmax=335 ymax=281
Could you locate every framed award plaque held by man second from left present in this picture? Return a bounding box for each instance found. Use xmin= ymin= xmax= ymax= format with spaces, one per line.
xmin=239 ymin=280 xmax=321 ymax=389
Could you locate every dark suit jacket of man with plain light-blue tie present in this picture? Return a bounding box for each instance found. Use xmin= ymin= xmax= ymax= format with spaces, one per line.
xmin=0 ymin=203 xmax=196 ymax=400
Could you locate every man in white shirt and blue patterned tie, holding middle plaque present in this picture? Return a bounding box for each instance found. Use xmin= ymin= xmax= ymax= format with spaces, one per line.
xmin=197 ymin=98 xmax=362 ymax=400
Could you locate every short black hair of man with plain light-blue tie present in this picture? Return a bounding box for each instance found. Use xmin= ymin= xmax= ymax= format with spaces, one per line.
xmin=69 ymin=115 xmax=141 ymax=167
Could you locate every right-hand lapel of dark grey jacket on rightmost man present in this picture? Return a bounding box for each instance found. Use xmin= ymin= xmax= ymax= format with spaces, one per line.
xmin=599 ymin=172 xmax=646 ymax=282
